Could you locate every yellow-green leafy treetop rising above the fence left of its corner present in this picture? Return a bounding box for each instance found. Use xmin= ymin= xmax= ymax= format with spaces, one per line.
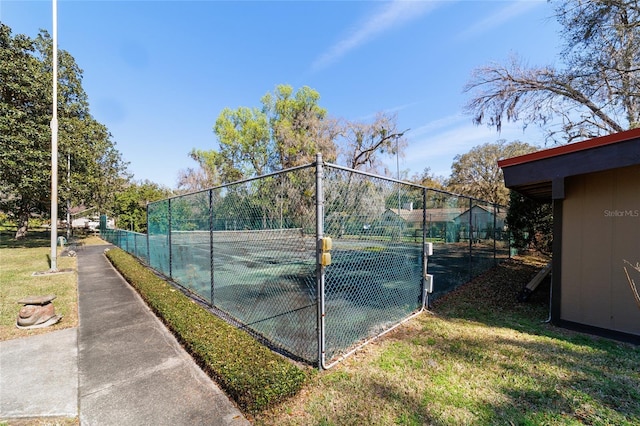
xmin=189 ymin=85 xmax=336 ymax=188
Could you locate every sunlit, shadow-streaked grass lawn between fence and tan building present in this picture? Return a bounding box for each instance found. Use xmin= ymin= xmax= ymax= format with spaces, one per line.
xmin=256 ymin=258 xmax=640 ymax=425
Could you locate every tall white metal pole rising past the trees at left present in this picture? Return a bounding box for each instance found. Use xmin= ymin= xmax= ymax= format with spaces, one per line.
xmin=51 ymin=0 xmax=58 ymax=271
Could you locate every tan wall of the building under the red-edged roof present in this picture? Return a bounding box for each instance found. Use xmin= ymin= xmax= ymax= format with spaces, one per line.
xmin=560 ymin=166 xmax=640 ymax=335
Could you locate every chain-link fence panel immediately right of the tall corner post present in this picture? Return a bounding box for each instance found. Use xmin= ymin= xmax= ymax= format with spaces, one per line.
xmin=323 ymin=165 xmax=424 ymax=359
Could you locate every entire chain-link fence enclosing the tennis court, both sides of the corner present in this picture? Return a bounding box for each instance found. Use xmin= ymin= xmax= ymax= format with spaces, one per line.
xmin=102 ymin=158 xmax=509 ymax=367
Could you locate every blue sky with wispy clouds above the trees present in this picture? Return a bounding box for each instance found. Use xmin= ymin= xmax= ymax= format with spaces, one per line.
xmin=0 ymin=0 xmax=560 ymax=188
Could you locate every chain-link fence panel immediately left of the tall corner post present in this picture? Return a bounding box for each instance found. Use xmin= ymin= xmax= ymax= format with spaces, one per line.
xmin=212 ymin=167 xmax=318 ymax=362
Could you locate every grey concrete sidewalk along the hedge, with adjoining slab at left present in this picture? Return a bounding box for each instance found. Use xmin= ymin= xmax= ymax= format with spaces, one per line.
xmin=0 ymin=246 xmax=249 ymax=425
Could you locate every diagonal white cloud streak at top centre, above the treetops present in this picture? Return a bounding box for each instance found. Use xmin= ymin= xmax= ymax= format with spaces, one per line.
xmin=311 ymin=0 xmax=439 ymax=71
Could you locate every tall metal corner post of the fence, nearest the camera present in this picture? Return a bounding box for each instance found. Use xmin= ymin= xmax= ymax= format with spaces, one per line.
xmin=316 ymin=153 xmax=325 ymax=369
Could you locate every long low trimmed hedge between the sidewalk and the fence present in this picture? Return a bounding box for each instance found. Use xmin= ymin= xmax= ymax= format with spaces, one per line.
xmin=107 ymin=248 xmax=313 ymax=414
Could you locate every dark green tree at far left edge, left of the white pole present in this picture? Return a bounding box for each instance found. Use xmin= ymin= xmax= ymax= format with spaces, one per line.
xmin=0 ymin=23 xmax=51 ymax=238
